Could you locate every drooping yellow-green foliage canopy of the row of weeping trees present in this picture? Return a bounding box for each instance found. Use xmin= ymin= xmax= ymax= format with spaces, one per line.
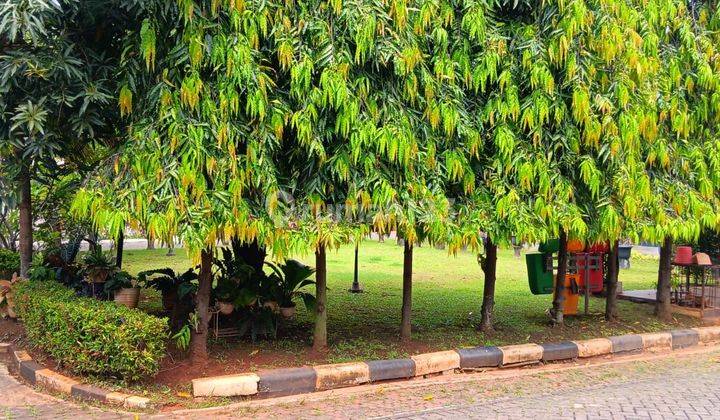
xmin=76 ymin=0 xmax=720 ymax=254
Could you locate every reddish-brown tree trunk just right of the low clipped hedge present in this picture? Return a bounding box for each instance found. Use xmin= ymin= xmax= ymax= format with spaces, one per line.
xmin=190 ymin=249 xmax=213 ymax=364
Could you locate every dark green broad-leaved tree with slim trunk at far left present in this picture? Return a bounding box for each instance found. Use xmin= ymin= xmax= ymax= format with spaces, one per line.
xmin=0 ymin=0 xmax=124 ymax=276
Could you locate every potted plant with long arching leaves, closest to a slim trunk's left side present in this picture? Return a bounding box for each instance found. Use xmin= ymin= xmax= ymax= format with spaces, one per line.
xmin=269 ymin=260 xmax=315 ymax=318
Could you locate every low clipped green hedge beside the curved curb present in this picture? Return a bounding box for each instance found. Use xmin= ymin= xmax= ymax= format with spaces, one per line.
xmin=15 ymin=281 xmax=168 ymax=381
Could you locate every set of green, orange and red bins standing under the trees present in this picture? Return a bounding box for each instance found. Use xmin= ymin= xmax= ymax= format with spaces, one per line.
xmin=525 ymin=239 xmax=610 ymax=315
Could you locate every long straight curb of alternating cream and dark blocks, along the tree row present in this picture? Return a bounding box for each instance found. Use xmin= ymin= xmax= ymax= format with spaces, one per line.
xmin=193 ymin=326 xmax=720 ymax=397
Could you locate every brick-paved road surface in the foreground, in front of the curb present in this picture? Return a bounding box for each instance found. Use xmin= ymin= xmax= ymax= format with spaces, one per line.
xmin=0 ymin=351 xmax=720 ymax=419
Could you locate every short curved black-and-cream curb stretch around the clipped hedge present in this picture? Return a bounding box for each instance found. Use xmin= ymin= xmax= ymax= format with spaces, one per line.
xmin=0 ymin=343 xmax=150 ymax=408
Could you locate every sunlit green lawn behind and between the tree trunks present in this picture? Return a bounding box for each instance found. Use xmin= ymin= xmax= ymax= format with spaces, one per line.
xmin=124 ymin=240 xmax=698 ymax=366
